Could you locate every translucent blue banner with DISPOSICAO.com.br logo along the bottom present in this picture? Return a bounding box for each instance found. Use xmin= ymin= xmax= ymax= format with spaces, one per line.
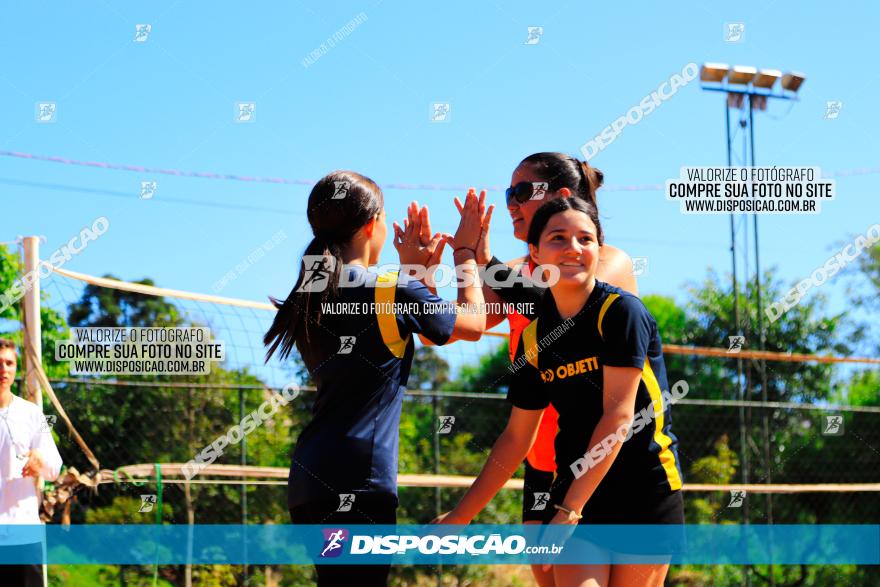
xmin=0 ymin=525 xmax=880 ymax=565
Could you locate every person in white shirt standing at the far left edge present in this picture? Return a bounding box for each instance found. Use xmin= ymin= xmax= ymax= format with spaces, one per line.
xmin=0 ymin=338 xmax=61 ymax=587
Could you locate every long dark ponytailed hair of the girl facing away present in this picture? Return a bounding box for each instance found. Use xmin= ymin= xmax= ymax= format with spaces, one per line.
xmin=263 ymin=171 xmax=383 ymax=361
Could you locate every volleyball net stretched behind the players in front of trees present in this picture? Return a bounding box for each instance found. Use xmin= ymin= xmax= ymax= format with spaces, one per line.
xmin=1 ymin=248 xmax=880 ymax=524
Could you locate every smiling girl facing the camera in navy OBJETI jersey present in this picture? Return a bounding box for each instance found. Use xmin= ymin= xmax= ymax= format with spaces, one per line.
xmin=441 ymin=198 xmax=687 ymax=587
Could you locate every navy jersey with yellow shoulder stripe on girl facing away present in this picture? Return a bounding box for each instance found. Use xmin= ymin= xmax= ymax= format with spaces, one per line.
xmin=288 ymin=266 xmax=456 ymax=507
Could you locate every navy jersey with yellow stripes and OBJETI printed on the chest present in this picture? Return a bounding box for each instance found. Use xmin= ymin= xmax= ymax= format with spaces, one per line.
xmin=507 ymin=281 xmax=682 ymax=495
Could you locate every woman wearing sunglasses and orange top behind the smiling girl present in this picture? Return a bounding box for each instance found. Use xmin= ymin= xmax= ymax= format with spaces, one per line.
xmin=458 ymin=152 xmax=638 ymax=587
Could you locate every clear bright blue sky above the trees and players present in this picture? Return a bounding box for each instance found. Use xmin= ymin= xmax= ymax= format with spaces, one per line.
xmin=0 ymin=0 xmax=880 ymax=378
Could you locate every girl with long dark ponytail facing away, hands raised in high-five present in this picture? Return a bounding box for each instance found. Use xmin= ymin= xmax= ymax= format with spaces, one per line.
xmin=263 ymin=171 xmax=491 ymax=586
